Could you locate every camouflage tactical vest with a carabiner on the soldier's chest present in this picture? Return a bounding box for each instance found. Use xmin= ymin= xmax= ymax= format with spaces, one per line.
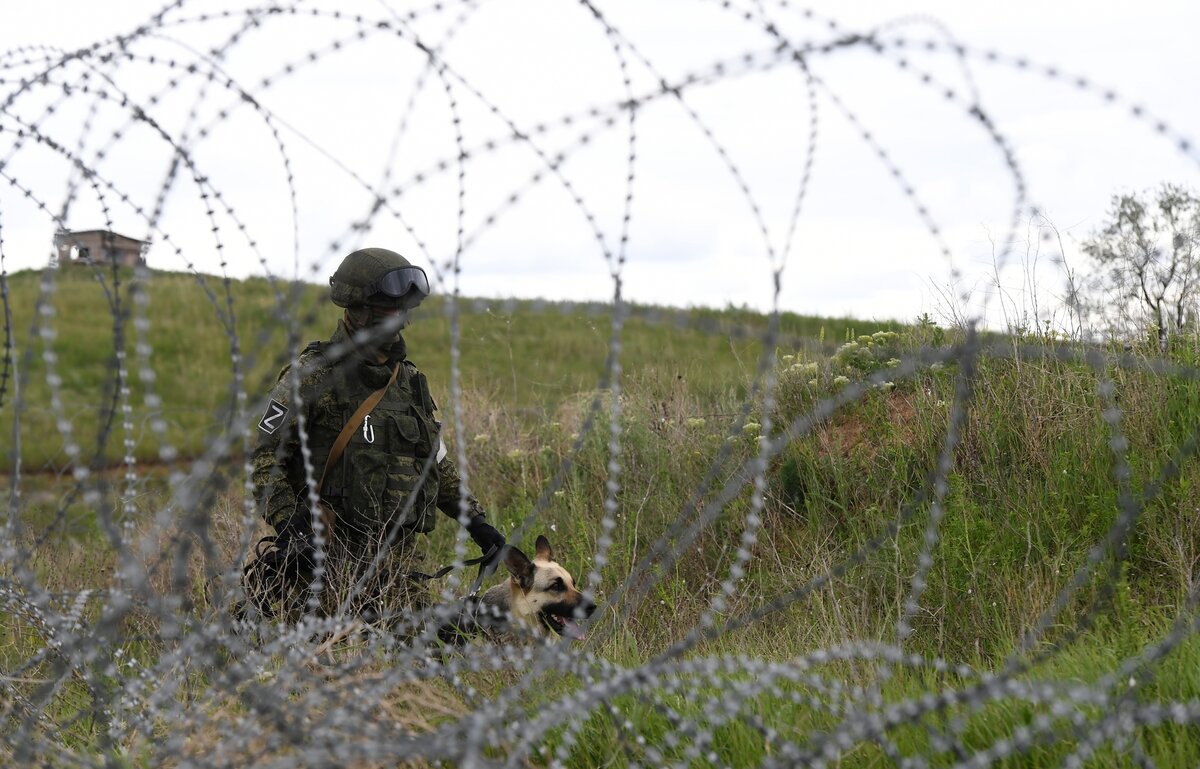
xmin=310 ymin=343 xmax=440 ymax=540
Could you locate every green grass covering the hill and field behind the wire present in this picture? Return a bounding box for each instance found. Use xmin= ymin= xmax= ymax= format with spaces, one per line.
xmin=0 ymin=263 xmax=1200 ymax=767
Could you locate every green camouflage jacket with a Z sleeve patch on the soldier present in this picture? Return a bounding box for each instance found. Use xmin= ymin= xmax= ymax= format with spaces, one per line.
xmin=251 ymin=322 xmax=484 ymax=536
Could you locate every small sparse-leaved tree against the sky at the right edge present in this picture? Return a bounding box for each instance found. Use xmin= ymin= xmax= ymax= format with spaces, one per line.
xmin=1082 ymin=185 xmax=1200 ymax=352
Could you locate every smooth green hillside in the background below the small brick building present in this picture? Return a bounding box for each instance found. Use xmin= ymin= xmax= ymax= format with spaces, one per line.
xmin=0 ymin=268 xmax=898 ymax=473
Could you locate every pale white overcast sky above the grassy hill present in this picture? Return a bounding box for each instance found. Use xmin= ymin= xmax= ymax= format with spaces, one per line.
xmin=0 ymin=0 xmax=1200 ymax=319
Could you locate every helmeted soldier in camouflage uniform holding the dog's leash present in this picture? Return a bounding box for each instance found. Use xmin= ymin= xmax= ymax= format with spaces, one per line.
xmin=246 ymin=248 xmax=504 ymax=618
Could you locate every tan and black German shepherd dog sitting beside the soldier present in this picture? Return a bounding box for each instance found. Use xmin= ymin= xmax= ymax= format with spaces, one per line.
xmin=438 ymin=535 xmax=596 ymax=644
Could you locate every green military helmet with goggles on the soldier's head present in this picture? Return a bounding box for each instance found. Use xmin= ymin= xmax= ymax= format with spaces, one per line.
xmin=329 ymin=248 xmax=430 ymax=310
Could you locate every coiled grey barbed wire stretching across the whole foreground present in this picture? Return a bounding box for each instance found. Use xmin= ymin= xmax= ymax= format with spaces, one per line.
xmin=0 ymin=0 xmax=1200 ymax=767
